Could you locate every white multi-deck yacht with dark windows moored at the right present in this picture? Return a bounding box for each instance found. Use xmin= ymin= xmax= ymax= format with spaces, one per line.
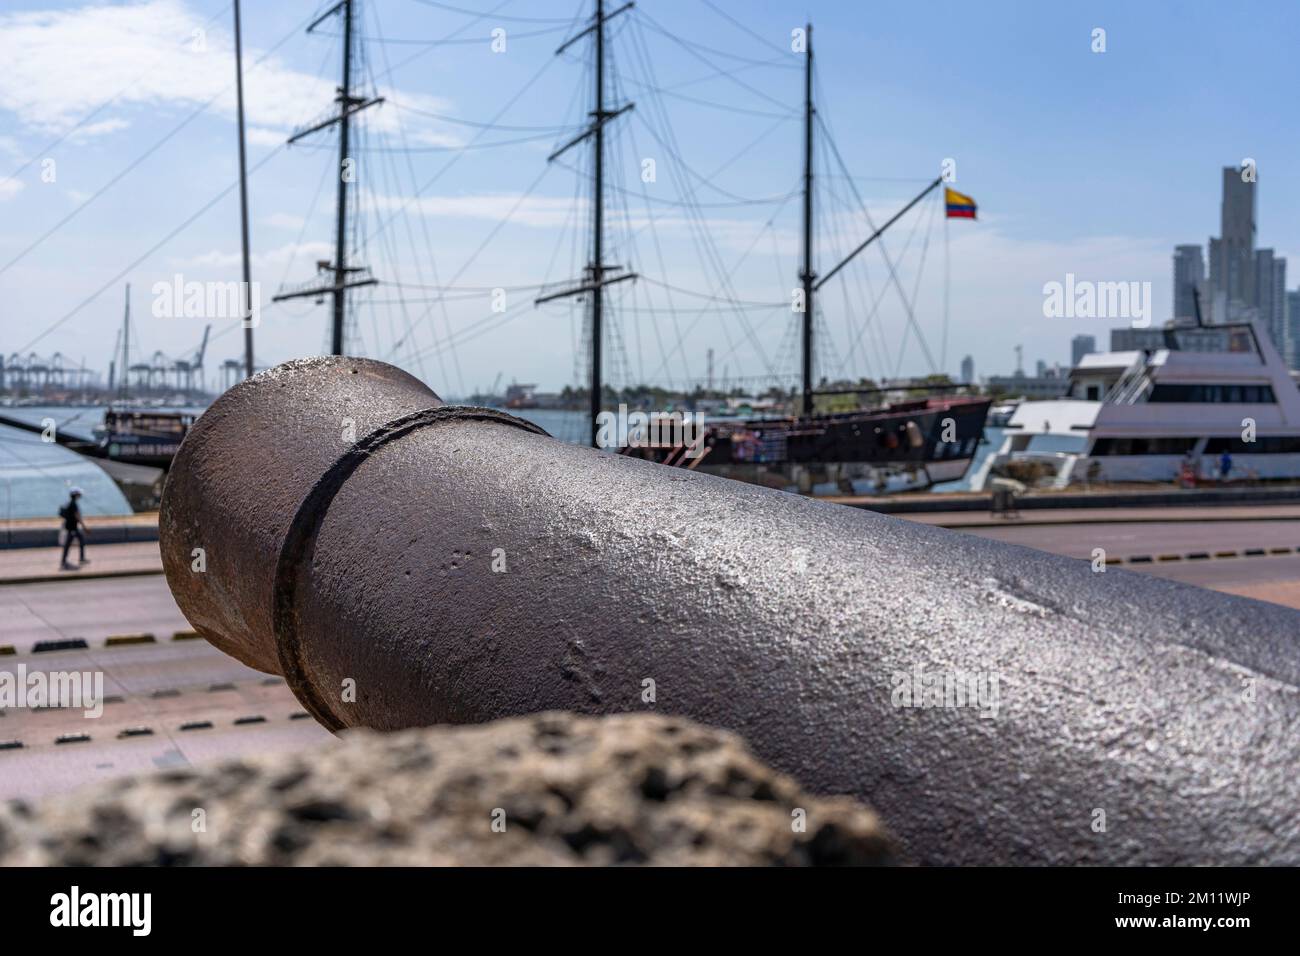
xmin=971 ymin=323 xmax=1300 ymax=490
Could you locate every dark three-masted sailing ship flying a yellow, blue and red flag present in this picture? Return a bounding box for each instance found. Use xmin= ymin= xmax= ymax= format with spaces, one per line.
xmin=258 ymin=0 xmax=991 ymax=493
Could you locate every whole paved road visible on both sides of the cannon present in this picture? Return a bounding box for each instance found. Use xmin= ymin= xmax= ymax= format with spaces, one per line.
xmin=0 ymin=510 xmax=1300 ymax=799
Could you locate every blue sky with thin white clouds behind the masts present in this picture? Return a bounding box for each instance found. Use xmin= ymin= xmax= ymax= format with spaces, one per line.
xmin=0 ymin=0 xmax=1300 ymax=397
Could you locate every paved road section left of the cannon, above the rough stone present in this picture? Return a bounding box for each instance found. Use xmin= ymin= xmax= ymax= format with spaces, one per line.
xmin=0 ymin=575 xmax=330 ymax=799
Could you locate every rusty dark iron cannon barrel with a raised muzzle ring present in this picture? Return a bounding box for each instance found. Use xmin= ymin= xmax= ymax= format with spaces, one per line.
xmin=160 ymin=358 xmax=1300 ymax=864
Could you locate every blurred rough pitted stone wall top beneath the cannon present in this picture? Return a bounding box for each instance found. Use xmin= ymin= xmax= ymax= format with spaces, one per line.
xmin=0 ymin=713 xmax=894 ymax=866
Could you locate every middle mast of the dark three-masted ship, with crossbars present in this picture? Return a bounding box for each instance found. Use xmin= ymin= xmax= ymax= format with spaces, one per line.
xmin=533 ymin=0 xmax=636 ymax=447
